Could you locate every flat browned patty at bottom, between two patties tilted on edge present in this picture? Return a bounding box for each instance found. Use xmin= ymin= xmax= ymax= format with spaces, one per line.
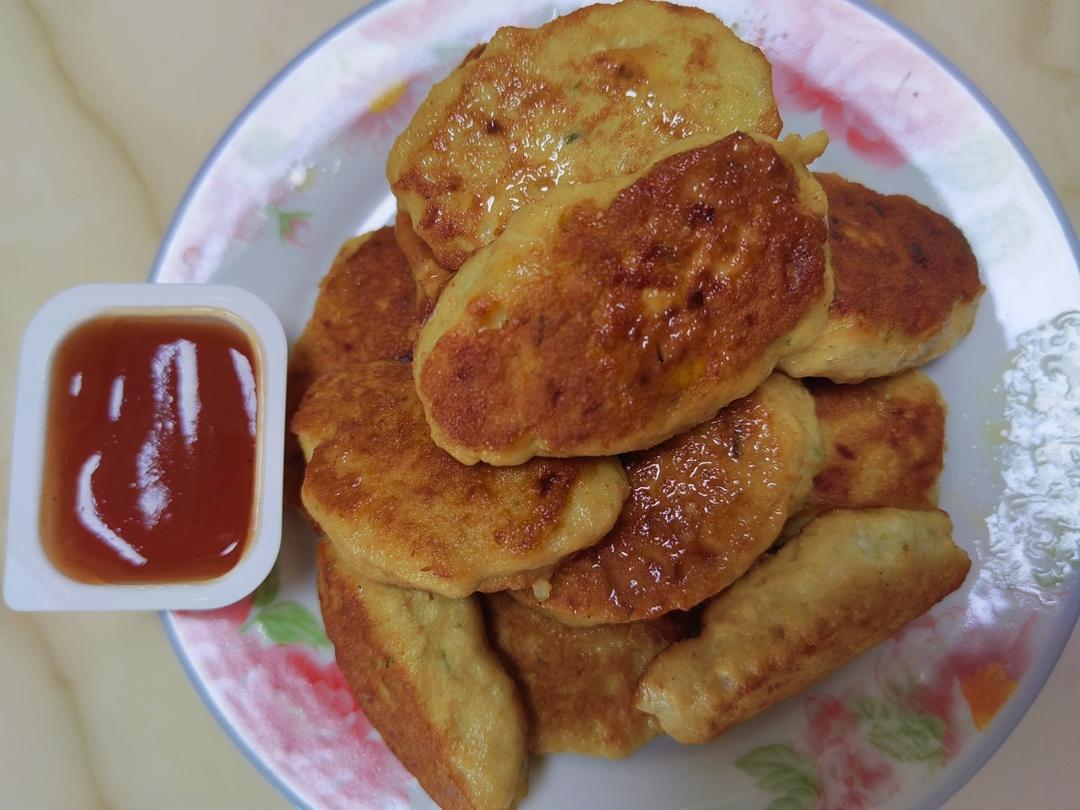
xmin=484 ymin=594 xmax=684 ymax=757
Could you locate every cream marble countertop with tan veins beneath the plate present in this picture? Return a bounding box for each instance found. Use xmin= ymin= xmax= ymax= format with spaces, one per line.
xmin=0 ymin=0 xmax=1080 ymax=810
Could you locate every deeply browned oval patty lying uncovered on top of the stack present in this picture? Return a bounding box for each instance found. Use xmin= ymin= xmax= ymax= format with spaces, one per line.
xmin=414 ymin=133 xmax=832 ymax=464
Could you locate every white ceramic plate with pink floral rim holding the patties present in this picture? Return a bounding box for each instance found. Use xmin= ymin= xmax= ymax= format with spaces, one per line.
xmin=153 ymin=0 xmax=1080 ymax=810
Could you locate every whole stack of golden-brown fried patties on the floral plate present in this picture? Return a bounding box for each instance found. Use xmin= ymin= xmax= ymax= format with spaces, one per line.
xmin=292 ymin=0 xmax=982 ymax=808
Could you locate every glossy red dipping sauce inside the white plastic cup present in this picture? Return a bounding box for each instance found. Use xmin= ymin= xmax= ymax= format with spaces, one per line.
xmin=41 ymin=315 xmax=259 ymax=583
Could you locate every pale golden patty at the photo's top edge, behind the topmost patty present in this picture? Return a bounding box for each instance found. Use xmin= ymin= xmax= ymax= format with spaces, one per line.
xmin=387 ymin=0 xmax=781 ymax=270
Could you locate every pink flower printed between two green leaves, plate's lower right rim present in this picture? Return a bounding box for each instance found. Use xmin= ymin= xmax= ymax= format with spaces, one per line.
xmin=800 ymin=697 xmax=900 ymax=810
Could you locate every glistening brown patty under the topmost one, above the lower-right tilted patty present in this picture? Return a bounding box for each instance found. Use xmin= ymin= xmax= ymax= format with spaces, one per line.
xmin=513 ymin=374 xmax=822 ymax=624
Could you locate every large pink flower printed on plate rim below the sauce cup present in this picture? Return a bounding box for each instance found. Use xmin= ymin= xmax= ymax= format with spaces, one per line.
xmin=173 ymin=599 xmax=411 ymax=809
